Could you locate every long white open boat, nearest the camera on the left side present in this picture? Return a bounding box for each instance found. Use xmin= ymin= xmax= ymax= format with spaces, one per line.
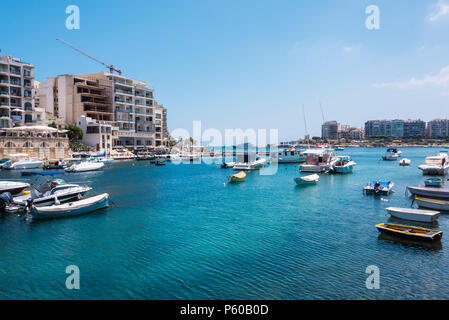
xmin=30 ymin=193 xmax=109 ymax=219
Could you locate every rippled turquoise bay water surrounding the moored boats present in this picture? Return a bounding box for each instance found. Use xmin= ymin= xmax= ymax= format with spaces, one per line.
xmin=0 ymin=148 xmax=449 ymax=299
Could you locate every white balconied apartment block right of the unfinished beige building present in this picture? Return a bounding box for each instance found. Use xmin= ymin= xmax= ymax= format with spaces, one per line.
xmin=86 ymin=72 xmax=168 ymax=149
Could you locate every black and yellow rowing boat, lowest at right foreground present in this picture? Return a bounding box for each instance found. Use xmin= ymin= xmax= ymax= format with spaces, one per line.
xmin=376 ymin=223 xmax=443 ymax=242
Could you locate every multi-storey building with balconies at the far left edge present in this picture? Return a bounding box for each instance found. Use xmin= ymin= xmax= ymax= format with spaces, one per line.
xmin=0 ymin=56 xmax=36 ymax=128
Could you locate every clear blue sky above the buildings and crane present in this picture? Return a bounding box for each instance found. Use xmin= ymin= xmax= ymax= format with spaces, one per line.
xmin=0 ymin=0 xmax=449 ymax=140
